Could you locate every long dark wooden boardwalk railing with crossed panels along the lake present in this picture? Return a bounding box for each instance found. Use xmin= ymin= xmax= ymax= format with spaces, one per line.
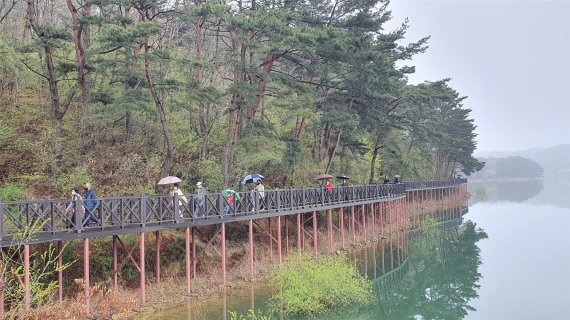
xmin=0 ymin=179 xmax=466 ymax=247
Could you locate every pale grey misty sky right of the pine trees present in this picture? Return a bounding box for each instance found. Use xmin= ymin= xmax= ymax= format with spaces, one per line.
xmin=389 ymin=0 xmax=570 ymax=151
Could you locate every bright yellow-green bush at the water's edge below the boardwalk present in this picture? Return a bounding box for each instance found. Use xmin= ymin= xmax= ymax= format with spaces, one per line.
xmin=271 ymin=254 xmax=373 ymax=315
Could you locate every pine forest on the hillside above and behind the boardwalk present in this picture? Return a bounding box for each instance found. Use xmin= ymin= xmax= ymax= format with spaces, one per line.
xmin=0 ymin=0 xmax=483 ymax=201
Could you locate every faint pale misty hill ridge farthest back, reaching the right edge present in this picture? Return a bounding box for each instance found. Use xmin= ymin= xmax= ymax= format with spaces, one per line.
xmin=475 ymin=144 xmax=570 ymax=181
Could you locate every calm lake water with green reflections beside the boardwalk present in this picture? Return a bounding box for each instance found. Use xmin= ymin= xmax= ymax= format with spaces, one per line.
xmin=156 ymin=181 xmax=570 ymax=320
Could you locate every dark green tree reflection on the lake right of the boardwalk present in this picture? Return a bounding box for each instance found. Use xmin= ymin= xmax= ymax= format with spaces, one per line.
xmin=370 ymin=220 xmax=487 ymax=319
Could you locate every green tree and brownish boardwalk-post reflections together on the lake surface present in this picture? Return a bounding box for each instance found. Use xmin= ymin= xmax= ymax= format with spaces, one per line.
xmin=153 ymin=208 xmax=487 ymax=320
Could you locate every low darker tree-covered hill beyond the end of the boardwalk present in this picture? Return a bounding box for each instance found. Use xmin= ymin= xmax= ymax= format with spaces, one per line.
xmin=470 ymin=156 xmax=544 ymax=180
